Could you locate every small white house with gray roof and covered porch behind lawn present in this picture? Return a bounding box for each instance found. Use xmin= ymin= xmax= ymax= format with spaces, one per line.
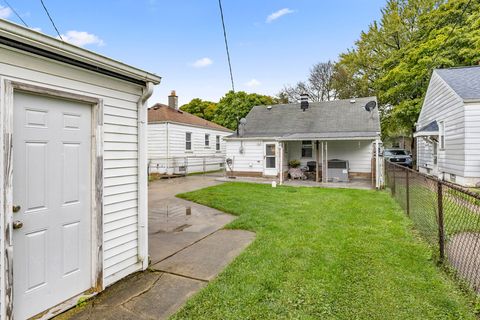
xmin=226 ymin=97 xmax=380 ymax=187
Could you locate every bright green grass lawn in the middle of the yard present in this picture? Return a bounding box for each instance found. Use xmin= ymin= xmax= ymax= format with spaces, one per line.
xmin=173 ymin=183 xmax=476 ymax=319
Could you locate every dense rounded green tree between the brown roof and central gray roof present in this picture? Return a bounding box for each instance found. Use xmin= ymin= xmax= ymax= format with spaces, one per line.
xmin=214 ymin=91 xmax=278 ymax=130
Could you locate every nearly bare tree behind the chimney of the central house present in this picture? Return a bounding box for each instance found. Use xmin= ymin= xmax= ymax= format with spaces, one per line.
xmin=278 ymin=60 xmax=337 ymax=102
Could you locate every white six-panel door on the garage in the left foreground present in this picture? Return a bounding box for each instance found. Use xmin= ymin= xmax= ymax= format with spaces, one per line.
xmin=13 ymin=92 xmax=92 ymax=319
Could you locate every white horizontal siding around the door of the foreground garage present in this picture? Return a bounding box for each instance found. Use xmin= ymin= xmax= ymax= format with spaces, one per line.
xmin=0 ymin=44 xmax=146 ymax=292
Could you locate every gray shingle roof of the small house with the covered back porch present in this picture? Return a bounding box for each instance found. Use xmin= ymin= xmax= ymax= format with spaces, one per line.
xmin=230 ymin=97 xmax=380 ymax=140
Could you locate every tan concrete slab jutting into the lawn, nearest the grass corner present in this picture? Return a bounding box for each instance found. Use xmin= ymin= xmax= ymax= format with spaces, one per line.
xmin=152 ymin=230 xmax=255 ymax=281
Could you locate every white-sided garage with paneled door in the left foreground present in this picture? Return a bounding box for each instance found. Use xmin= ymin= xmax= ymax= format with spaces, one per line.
xmin=0 ymin=20 xmax=160 ymax=320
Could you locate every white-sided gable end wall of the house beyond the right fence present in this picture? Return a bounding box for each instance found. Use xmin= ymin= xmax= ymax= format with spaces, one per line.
xmin=417 ymin=72 xmax=465 ymax=176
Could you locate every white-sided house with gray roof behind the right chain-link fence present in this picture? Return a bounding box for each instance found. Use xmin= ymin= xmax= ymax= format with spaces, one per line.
xmin=414 ymin=66 xmax=480 ymax=187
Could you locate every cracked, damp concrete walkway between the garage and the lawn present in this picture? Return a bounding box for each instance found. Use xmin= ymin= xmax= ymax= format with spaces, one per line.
xmin=57 ymin=176 xmax=255 ymax=320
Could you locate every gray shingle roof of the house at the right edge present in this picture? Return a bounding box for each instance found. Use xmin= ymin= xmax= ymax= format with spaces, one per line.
xmin=435 ymin=66 xmax=480 ymax=100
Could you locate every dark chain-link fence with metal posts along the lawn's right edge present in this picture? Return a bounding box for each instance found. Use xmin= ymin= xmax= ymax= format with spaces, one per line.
xmin=385 ymin=162 xmax=480 ymax=292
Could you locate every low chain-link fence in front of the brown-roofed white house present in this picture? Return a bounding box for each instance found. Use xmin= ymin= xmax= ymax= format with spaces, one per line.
xmin=148 ymin=156 xmax=225 ymax=178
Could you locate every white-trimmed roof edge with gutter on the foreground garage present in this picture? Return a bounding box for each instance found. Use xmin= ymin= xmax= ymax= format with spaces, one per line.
xmin=0 ymin=19 xmax=161 ymax=85
